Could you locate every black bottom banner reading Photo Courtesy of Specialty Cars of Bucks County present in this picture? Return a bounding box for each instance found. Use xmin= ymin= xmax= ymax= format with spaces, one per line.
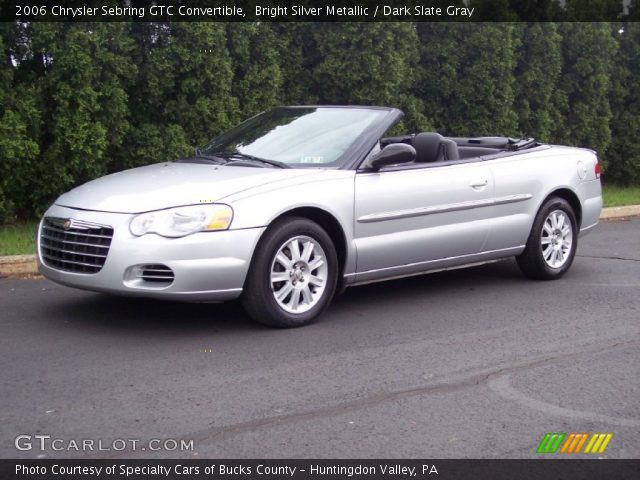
xmin=5 ymin=459 xmax=640 ymax=480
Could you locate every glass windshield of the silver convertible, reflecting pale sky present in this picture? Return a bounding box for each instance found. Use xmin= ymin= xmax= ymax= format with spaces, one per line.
xmin=200 ymin=107 xmax=388 ymax=167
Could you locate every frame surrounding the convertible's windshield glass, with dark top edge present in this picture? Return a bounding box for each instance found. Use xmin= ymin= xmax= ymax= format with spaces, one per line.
xmin=199 ymin=105 xmax=404 ymax=170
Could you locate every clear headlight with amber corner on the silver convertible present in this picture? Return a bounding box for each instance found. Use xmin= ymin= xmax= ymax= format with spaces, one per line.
xmin=129 ymin=204 xmax=233 ymax=237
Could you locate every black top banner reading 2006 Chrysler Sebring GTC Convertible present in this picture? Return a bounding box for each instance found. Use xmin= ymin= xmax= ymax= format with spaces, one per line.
xmin=0 ymin=0 xmax=640 ymax=22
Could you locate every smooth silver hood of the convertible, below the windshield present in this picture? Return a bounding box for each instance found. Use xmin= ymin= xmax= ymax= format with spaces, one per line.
xmin=55 ymin=162 xmax=320 ymax=213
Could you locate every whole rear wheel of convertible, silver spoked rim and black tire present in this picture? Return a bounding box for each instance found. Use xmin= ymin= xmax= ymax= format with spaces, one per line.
xmin=517 ymin=197 xmax=578 ymax=280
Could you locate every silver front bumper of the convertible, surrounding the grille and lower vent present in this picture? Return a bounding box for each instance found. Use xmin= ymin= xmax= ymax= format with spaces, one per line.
xmin=37 ymin=205 xmax=265 ymax=302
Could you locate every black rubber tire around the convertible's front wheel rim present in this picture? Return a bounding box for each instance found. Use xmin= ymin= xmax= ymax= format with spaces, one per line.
xmin=241 ymin=217 xmax=338 ymax=328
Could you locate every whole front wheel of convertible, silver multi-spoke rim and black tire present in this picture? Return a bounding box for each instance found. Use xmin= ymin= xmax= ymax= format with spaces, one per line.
xmin=242 ymin=217 xmax=338 ymax=328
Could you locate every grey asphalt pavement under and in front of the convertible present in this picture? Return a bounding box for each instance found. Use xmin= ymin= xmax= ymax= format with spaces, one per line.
xmin=0 ymin=220 xmax=640 ymax=458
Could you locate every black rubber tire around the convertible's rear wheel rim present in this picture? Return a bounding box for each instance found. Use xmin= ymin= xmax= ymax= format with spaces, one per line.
xmin=516 ymin=197 xmax=579 ymax=280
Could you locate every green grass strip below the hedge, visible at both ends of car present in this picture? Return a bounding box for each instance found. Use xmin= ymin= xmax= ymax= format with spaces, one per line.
xmin=0 ymin=185 xmax=640 ymax=256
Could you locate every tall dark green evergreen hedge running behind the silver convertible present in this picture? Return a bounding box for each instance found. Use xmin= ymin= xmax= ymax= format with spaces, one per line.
xmin=0 ymin=12 xmax=640 ymax=223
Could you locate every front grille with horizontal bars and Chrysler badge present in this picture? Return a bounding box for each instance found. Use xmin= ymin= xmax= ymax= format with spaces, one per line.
xmin=40 ymin=217 xmax=113 ymax=273
